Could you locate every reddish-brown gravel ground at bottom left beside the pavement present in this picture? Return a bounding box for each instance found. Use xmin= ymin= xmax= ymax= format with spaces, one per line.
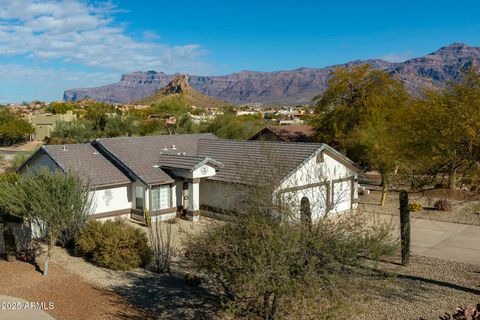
xmin=0 ymin=261 xmax=149 ymax=320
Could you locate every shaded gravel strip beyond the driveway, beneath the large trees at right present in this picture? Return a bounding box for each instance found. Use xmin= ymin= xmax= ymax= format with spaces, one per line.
xmin=359 ymin=190 xmax=480 ymax=226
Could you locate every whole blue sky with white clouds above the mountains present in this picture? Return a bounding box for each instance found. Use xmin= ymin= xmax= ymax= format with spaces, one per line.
xmin=0 ymin=0 xmax=480 ymax=103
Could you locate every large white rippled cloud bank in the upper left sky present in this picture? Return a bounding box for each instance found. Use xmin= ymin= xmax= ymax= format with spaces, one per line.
xmin=0 ymin=0 xmax=206 ymax=72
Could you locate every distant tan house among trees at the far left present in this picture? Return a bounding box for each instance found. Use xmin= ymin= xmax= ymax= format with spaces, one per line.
xmin=25 ymin=111 xmax=77 ymax=141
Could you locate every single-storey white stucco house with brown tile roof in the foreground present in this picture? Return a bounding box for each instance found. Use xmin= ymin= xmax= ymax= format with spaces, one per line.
xmin=19 ymin=134 xmax=358 ymax=221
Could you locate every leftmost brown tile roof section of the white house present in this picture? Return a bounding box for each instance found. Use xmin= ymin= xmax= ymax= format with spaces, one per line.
xmin=39 ymin=143 xmax=131 ymax=187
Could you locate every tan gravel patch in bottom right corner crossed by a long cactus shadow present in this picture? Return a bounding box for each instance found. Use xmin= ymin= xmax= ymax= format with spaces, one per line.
xmin=354 ymin=256 xmax=480 ymax=319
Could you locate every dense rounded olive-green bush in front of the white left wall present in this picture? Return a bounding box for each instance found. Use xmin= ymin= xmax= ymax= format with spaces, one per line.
xmin=75 ymin=221 xmax=152 ymax=270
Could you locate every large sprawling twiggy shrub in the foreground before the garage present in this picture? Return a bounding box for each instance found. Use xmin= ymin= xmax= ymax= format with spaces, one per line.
xmin=185 ymin=212 xmax=396 ymax=319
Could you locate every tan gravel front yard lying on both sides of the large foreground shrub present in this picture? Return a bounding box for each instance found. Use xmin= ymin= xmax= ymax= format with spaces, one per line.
xmin=29 ymin=218 xmax=480 ymax=320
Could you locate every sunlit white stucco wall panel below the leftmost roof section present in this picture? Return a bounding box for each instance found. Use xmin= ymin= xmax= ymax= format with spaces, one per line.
xmin=90 ymin=184 xmax=132 ymax=214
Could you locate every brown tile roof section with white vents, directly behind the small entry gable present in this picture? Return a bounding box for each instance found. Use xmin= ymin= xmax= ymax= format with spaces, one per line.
xmin=95 ymin=133 xmax=216 ymax=184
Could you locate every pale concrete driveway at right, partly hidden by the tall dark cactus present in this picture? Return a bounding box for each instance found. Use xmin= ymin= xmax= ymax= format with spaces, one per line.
xmin=379 ymin=214 xmax=480 ymax=265
